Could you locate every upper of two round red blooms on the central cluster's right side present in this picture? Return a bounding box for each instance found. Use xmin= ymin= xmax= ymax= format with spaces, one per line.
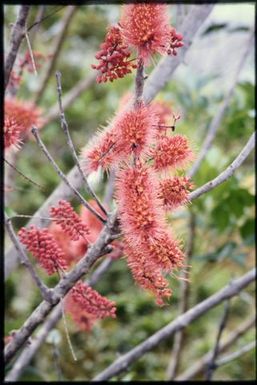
xmin=151 ymin=135 xmax=193 ymax=171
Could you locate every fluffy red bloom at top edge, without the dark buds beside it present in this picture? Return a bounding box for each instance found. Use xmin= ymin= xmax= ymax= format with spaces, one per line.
xmin=120 ymin=3 xmax=170 ymax=63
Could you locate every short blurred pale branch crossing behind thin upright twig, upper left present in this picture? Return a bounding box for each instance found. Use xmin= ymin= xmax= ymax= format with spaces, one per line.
xmin=45 ymin=73 xmax=97 ymax=124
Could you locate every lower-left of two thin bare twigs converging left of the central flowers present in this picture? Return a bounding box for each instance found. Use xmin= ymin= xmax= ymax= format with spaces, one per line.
xmin=31 ymin=127 xmax=106 ymax=223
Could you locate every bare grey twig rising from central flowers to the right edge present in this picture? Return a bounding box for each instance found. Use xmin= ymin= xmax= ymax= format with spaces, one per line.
xmin=189 ymin=132 xmax=255 ymax=201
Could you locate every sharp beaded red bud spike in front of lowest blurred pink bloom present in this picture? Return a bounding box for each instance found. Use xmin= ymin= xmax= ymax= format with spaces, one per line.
xmin=65 ymin=281 xmax=116 ymax=319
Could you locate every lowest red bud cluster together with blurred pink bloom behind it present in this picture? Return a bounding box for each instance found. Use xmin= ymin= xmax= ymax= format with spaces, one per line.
xmin=65 ymin=281 xmax=116 ymax=331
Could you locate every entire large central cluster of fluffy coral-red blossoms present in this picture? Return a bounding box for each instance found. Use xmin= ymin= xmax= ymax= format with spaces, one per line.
xmin=82 ymin=100 xmax=193 ymax=305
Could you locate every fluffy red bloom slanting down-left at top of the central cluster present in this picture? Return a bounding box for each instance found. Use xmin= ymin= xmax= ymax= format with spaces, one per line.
xmin=82 ymin=103 xmax=158 ymax=173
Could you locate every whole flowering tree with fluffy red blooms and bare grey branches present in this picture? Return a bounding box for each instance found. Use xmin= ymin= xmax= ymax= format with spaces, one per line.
xmin=4 ymin=3 xmax=255 ymax=381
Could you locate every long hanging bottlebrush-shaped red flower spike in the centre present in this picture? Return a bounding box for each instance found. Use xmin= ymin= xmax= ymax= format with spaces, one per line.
xmin=116 ymin=163 xmax=183 ymax=304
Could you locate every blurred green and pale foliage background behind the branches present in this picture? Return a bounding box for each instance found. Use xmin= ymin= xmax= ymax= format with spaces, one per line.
xmin=5 ymin=4 xmax=255 ymax=381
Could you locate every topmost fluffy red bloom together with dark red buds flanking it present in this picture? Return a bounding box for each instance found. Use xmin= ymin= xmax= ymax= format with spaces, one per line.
xmin=92 ymin=3 xmax=183 ymax=83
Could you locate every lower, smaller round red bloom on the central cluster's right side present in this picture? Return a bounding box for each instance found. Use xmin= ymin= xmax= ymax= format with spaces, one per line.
xmin=159 ymin=176 xmax=193 ymax=210
